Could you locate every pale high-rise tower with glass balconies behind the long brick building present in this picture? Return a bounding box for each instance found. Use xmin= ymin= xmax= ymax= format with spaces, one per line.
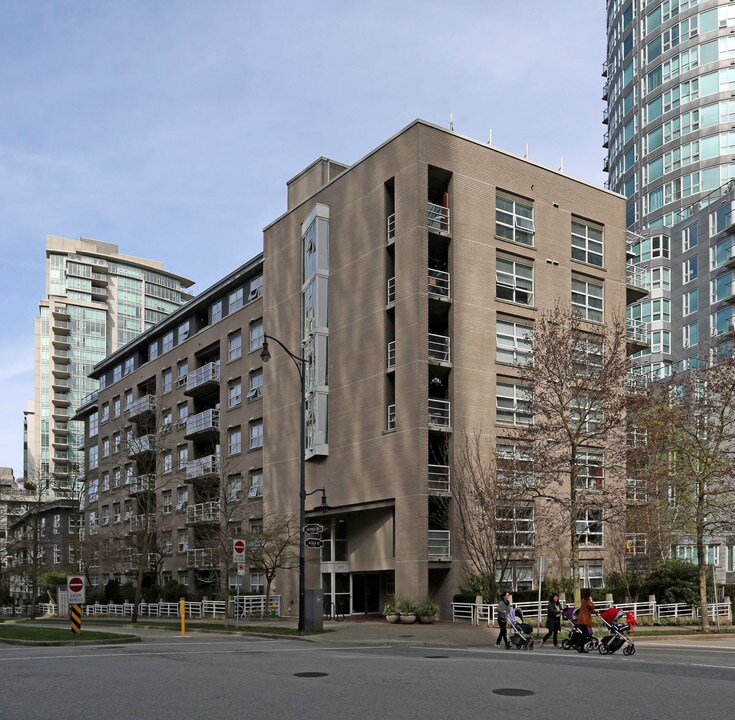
xmin=30 ymin=235 xmax=192 ymax=491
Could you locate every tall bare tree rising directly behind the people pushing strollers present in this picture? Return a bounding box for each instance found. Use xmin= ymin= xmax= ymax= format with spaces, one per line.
xmin=516 ymin=305 xmax=628 ymax=603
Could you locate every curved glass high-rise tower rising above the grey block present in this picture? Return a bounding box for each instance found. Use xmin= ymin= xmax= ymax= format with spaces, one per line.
xmin=603 ymin=0 xmax=735 ymax=230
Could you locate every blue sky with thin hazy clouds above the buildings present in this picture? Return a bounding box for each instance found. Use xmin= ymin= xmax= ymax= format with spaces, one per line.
xmin=0 ymin=0 xmax=605 ymax=477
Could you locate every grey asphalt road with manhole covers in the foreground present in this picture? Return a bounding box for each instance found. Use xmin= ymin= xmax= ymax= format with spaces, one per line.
xmin=0 ymin=631 xmax=735 ymax=720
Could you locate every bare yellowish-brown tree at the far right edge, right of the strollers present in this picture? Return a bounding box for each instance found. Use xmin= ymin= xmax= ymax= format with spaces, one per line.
xmin=636 ymin=351 xmax=735 ymax=632
